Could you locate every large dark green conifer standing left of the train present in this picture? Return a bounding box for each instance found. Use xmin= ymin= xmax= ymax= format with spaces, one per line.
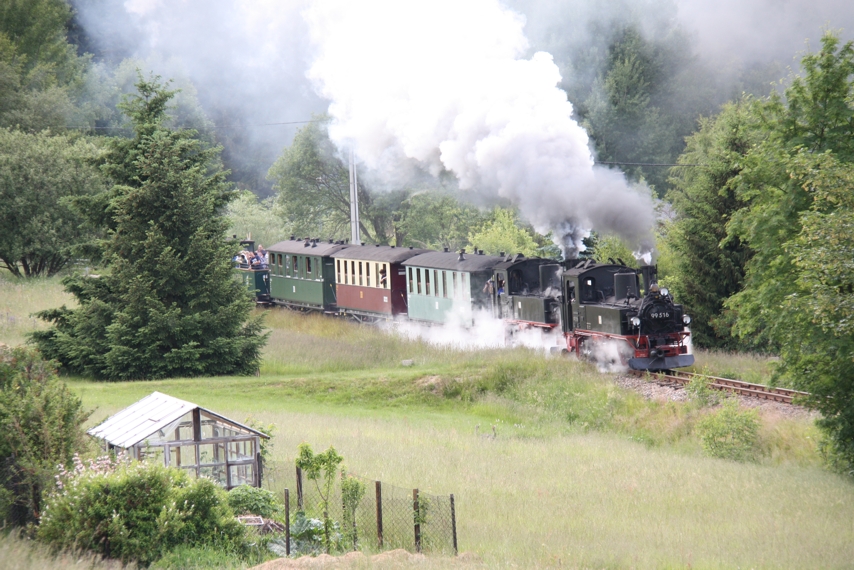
xmin=32 ymin=77 xmax=266 ymax=380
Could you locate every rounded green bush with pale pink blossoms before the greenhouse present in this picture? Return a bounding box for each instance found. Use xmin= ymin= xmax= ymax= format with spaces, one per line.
xmin=38 ymin=460 xmax=246 ymax=566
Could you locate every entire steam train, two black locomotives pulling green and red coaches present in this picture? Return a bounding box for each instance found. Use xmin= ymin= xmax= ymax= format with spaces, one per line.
xmin=235 ymin=236 xmax=694 ymax=371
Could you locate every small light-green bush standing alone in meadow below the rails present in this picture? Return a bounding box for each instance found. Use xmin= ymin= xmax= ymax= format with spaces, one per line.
xmin=697 ymin=398 xmax=759 ymax=461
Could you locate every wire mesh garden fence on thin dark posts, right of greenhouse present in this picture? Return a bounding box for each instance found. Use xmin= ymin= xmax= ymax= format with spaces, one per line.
xmin=264 ymin=462 xmax=457 ymax=555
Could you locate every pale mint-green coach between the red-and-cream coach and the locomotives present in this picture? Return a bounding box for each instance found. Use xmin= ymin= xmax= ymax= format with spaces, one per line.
xmin=401 ymin=250 xmax=503 ymax=324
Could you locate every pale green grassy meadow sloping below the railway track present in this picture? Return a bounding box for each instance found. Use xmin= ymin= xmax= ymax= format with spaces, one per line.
xmin=0 ymin=274 xmax=854 ymax=568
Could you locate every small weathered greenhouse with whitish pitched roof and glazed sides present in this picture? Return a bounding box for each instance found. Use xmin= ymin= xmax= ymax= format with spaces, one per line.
xmin=87 ymin=392 xmax=269 ymax=489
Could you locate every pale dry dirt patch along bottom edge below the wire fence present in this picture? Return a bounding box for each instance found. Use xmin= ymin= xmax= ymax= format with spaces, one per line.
xmin=250 ymin=549 xmax=483 ymax=570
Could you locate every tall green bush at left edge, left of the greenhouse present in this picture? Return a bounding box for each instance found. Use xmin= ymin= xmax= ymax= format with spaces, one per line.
xmin=0 ymin=346 xmax=89 ymax=526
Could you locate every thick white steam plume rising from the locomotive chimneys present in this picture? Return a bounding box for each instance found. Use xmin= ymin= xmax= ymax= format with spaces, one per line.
xmin=304 ymin=0 xmax=654 ymax=257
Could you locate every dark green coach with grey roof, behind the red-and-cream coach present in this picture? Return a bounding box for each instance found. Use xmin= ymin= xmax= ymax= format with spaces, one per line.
xmin=267 ymin=239 xmax=349 ymax=311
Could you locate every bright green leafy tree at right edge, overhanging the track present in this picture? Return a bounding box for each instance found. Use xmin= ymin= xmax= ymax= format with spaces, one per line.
xmin=726 ymin=33 xmax=854 ymax=466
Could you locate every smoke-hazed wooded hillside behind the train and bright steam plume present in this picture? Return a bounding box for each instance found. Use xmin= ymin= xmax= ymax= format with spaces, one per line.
xmin=0 ymin=0 xmax=854 ymax=461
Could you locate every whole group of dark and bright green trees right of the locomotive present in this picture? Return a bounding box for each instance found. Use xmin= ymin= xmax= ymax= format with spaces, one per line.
xmin=664 ymin=33 xmax=854 ymax=471
